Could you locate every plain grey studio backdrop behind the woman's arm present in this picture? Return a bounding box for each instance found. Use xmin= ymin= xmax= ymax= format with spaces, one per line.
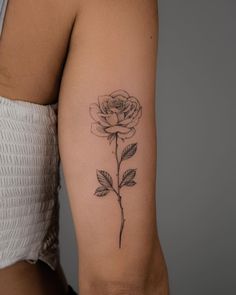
xmin=57 ymin=0 xmax=236 ymax=295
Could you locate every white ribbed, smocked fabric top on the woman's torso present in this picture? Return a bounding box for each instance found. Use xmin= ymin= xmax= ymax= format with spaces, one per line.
xmin=0 ymin=96 xmax=60 ymax=270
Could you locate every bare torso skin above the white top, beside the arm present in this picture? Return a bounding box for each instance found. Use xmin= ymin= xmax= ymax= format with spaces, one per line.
xmin=0 ymin=0 xmax=76 ymax=104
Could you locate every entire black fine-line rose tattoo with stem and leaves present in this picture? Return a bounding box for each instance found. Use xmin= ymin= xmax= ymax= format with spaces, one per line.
xmin=89 ymin=89 xmax=142 ymax=248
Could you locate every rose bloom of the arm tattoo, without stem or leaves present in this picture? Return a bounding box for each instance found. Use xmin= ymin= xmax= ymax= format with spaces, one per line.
xmin=89 ymin=90 xmax=142 ymax=142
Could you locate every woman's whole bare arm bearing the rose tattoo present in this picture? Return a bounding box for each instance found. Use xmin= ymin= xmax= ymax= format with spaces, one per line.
xmin=59 ymin=0 xmax=168 ymax=295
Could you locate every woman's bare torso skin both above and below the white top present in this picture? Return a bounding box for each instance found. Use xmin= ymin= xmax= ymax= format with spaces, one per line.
xmin=0 ymin=0 xmax=77 ymax=295
